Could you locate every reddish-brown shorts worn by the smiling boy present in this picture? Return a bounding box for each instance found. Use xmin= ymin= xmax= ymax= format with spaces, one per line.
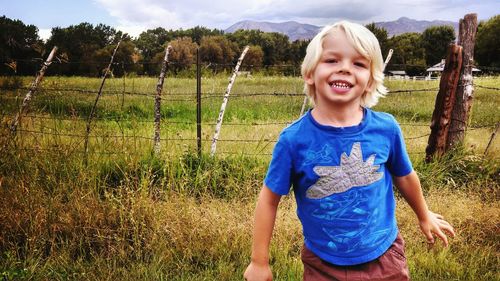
xmin=301 ymin=233 xmax=410 ymax=281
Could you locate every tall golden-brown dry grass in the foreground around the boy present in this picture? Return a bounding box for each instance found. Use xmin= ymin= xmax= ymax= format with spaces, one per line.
xmin=0 ymin=148 xmax=500 ymax=280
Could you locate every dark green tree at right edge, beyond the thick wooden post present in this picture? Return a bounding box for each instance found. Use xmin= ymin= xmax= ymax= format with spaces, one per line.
xmin=474 ymin=15 xmax=500 ymax=71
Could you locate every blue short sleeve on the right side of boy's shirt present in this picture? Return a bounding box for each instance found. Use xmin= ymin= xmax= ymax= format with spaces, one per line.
xmin=387 ymin=121 xmax=413 ymax=177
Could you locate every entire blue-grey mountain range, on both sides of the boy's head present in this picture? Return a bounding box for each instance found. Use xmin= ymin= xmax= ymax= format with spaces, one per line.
xmin=224 ymin=17 xmax=458 ymax=41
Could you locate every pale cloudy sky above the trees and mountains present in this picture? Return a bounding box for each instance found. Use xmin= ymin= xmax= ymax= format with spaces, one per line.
xmin=94 ymin=0 xmax=500 ymax=36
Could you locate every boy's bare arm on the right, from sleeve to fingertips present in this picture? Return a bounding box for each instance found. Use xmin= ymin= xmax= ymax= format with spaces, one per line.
xmin=394 ymin=168 xmax=455 ymax=246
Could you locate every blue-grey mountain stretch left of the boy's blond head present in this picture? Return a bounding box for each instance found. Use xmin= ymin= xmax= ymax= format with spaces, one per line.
xmin=224 ymin=20 xmax=321 ymax=41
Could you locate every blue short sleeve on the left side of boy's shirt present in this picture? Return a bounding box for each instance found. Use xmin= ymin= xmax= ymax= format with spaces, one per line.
xmin=264 ymin=134 xmax=292 ymax=195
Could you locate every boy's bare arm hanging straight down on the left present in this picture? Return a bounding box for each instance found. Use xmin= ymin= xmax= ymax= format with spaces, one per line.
xmin=244 ymin=185 xmax=281 ymax=281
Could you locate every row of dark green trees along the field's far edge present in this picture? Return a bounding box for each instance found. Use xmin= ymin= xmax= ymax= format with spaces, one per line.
xmin=0 ymin=15 xmax=500 ymax=77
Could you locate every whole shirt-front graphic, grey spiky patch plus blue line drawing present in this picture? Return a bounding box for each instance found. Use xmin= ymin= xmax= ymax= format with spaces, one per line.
xmin=306 ymin=142 xmax=391 ymax=253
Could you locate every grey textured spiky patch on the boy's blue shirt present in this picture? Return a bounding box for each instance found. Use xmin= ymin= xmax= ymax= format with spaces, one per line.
xmin=306 ymin=142 xmax=384 ymax=199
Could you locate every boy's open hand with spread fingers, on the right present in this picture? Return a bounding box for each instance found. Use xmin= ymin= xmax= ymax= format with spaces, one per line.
xmin=419 ymin=211 xmax=455 ymax=247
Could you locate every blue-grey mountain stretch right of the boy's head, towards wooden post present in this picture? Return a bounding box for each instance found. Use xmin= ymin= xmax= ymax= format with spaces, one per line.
xmin=375 ymin=17 xmax=458 ymax=37
